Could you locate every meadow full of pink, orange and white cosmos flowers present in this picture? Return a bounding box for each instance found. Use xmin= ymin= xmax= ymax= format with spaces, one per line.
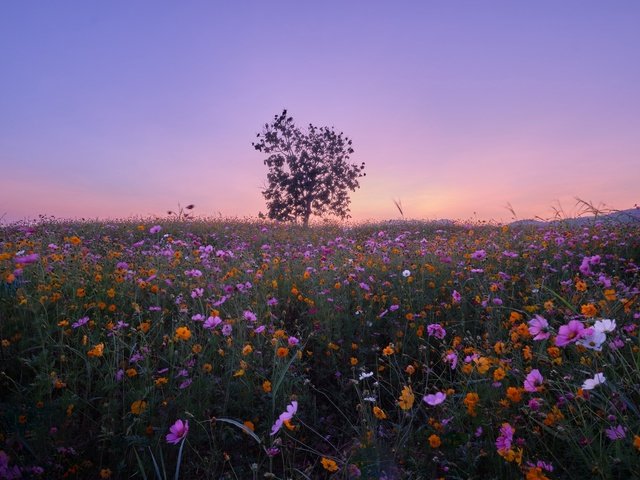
xmin=0 ymin=219 xmax=640 ymax=480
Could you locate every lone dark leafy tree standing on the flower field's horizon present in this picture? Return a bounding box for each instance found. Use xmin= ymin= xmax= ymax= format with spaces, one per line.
xmin=252 ymin=110 xmax=366 ymax=226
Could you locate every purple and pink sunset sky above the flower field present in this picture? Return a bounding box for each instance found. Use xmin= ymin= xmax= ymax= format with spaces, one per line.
xmin=0 ymin=0 xmax=640 ymax=223
